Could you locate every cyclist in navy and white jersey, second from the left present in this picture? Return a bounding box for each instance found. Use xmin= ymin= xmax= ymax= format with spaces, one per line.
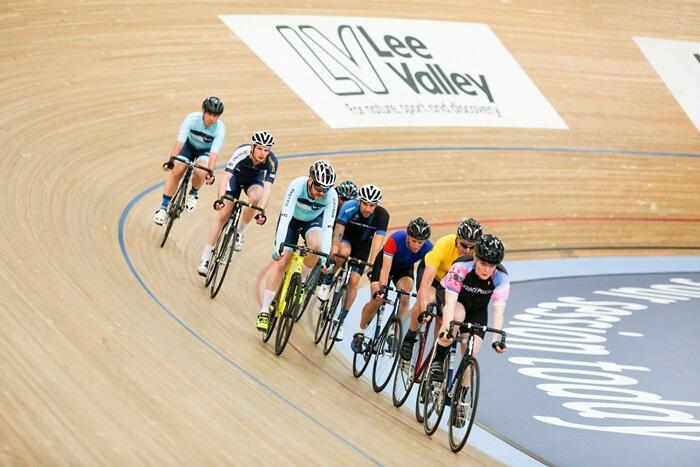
xmin=197 ymin=130 xmax=278 ymax=277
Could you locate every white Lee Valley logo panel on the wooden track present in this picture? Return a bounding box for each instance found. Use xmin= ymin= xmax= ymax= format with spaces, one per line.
xmin=220 ymin=16 xmax=567 ymax=129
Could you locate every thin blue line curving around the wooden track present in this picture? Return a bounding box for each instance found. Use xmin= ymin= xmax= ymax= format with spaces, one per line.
xmin=118 ymin=146 xmax=700 ymax=465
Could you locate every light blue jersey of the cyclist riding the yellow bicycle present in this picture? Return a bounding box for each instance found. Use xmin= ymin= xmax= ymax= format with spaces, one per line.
xmin=275 ymin=176 xmax=338 ymax=253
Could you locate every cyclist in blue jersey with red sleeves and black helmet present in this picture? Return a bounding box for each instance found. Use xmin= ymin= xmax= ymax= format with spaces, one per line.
xmin=351 ymin=217 xmax=433 ymax=353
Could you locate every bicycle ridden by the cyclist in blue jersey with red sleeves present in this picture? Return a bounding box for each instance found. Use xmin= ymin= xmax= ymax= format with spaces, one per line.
xmin=352 ymin=286 xmax=417 ymax=392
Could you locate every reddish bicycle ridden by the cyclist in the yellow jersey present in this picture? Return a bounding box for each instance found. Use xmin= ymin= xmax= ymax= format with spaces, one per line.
xmin=391 ymin=303 xmax=437 ymax=410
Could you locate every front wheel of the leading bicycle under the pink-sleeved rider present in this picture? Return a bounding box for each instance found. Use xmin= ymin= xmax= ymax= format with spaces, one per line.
xmin=449 ymin=357 xmax=479 ymax=452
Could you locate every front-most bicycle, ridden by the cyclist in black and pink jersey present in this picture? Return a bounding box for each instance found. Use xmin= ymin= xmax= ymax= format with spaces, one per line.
xmin=423 ymin=321 xmax=506 ymax=452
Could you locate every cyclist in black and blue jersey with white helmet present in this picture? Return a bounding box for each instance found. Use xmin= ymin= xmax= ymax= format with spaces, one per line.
xmin=319 ymin=184 xmax=389 ymax=341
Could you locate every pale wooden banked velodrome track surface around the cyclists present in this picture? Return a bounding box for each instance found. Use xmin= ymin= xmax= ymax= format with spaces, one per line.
xmin=0 ymin=0 xmax=700 ymax=465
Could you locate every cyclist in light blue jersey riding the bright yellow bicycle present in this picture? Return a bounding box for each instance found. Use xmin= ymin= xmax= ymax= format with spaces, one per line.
xmin=256 ymin=160 xmax=338 ymax=331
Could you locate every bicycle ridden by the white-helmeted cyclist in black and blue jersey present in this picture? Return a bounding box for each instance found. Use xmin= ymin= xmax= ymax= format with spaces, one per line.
xmin=314 ymin=255 xmax=371 ymax=355
